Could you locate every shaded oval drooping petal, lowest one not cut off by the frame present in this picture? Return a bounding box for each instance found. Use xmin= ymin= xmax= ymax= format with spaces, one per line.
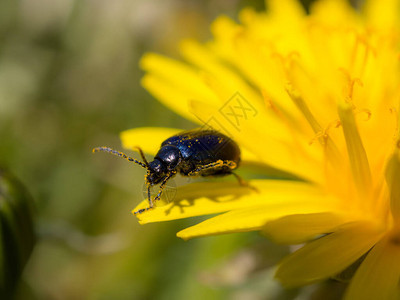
xmin=276 ymin=221 xmax=382 ymax=287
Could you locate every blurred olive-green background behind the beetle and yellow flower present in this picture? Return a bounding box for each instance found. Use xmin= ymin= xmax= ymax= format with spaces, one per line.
xmin=0 ymin=0 xmax=350 ymax=299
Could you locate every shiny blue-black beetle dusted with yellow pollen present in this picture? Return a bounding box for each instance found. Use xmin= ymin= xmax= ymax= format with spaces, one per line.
xmin=93 ymin=129 xmax=248 ymax=214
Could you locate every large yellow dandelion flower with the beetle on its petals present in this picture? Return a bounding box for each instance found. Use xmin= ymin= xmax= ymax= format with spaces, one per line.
xmin=121 ymin=0 xmax=400 ymax=299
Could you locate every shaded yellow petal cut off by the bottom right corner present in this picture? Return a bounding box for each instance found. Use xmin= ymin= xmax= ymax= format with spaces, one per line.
xmin=345 ymin=238 xmax=400 ymax=300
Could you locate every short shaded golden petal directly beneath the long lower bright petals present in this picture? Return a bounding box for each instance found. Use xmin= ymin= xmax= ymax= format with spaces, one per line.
xmin=262 ymin=212 xmax=349 ymax=245
